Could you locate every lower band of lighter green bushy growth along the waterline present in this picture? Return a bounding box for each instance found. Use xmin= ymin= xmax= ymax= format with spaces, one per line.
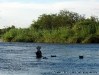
xmin=3 ymin=25 xmax=99 ymax=43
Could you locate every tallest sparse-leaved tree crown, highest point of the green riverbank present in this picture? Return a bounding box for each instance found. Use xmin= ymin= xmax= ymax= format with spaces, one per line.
xmin=58 ymin=10 xmax=85 ymax=27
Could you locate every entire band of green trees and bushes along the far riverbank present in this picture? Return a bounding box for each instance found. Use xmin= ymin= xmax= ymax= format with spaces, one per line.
xmin=0 ymin=10 xmax=99 ymax=43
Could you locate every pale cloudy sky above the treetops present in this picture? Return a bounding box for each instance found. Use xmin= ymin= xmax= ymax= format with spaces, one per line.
xmin=0 ymin=0 xmax=99 ymax=29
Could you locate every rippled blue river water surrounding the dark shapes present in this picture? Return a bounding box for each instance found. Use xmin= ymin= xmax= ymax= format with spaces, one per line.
xmin=0 ymin=42 xmax=99 ymax=75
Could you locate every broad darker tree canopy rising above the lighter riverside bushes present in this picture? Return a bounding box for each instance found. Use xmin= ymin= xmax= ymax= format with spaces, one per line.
xmin=30 ymin=10 xmax=85 ymax=30
